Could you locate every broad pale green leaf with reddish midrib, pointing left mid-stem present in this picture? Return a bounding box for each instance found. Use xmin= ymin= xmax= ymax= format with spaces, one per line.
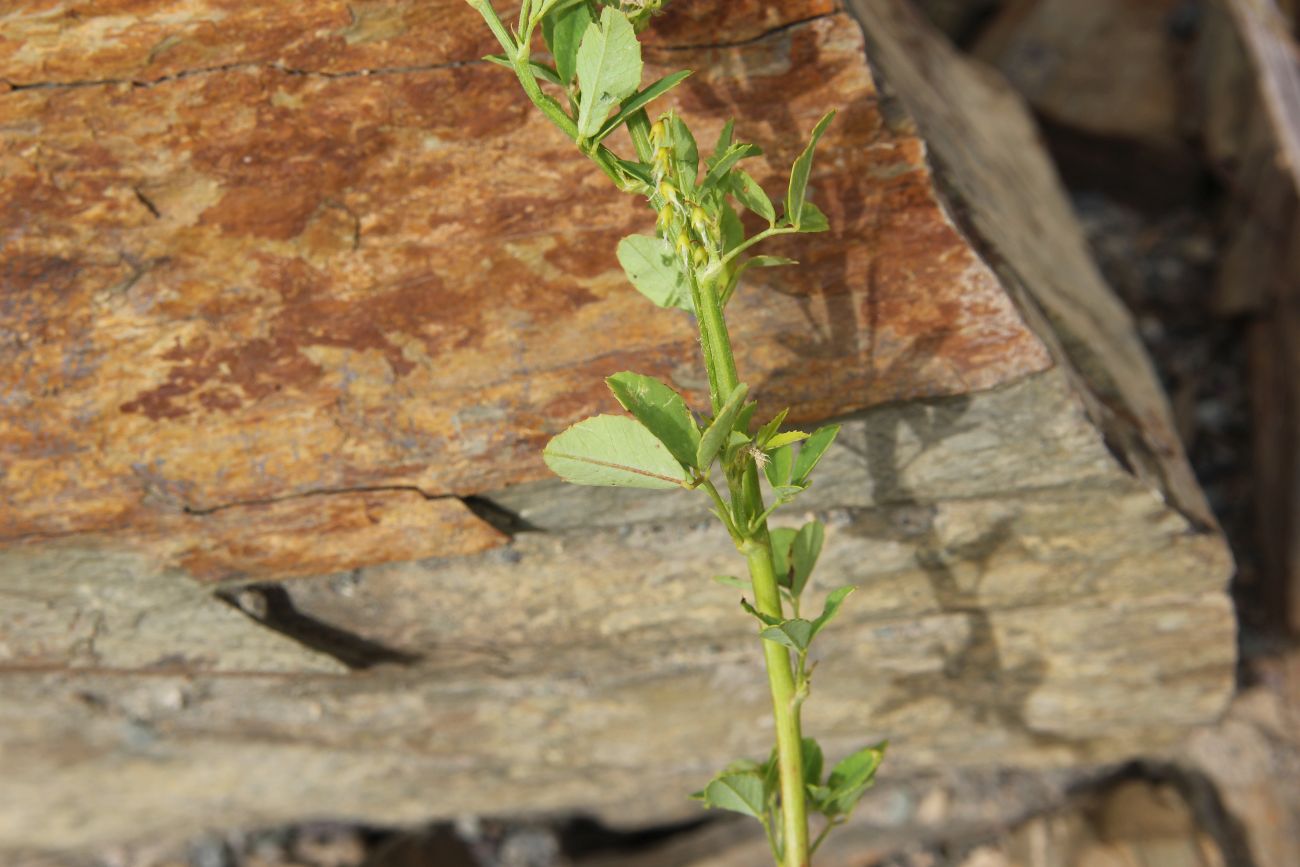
xmin=542 ymin=416 xmax=689 ymax=490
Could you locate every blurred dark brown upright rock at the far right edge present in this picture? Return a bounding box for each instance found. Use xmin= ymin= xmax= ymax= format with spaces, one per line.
xmin=1196 ymin=0 xmax=1300 ymax=634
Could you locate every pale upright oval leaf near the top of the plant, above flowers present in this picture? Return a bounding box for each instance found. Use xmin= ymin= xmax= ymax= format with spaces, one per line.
xmin=577 ymin=6 xmax=641 ymax=139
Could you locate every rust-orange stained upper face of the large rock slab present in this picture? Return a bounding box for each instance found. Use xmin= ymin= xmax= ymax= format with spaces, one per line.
xmin=0 ymin=3 xmax=1049 ymax=576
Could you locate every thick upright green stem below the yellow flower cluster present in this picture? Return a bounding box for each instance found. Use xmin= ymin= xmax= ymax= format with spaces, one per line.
xmin=694 ymin=277 xmax=809 ymax=867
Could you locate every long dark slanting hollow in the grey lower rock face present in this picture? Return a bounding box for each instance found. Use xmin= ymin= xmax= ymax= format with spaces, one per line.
xmin=215 ymin=584 xmax=421 ymax=671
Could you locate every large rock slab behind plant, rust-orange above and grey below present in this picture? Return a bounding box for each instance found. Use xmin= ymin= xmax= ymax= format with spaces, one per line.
xmin=0 ymin=0 xmax=1234 ymax=849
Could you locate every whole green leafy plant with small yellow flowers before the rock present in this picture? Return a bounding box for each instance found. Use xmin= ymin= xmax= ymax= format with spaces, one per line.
xmin=467 ymin=0 xmax=884 ymax=867
